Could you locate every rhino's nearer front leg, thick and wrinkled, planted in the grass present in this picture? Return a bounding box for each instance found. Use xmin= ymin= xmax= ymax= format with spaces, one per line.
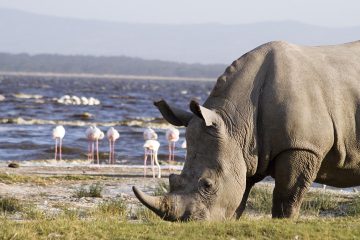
xmin=272 ymin=150 xmax=321 ymax=218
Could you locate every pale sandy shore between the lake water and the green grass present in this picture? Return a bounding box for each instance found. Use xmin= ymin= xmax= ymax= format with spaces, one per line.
xmin=0 ymin=162 xmax=183 ymax=219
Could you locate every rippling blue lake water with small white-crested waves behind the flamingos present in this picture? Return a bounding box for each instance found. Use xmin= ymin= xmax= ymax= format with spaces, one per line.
xmin=0 ymin=76 xmax=214 ymax=164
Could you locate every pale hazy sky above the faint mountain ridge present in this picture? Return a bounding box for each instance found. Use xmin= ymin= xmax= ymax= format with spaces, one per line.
xmin=0 ymin=0 xmax=360 ymax=27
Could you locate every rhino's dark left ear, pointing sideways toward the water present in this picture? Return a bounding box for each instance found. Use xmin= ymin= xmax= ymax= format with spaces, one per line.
xmin=154 ymin=99 xmax=193 ymax=127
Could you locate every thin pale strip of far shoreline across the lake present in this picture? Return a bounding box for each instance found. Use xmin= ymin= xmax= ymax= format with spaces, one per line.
xmin=0 ymin=71 xmax=216 ymax=82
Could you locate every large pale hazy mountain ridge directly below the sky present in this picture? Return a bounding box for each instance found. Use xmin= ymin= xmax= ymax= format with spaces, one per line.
xmin=0 ymin=9 xmax=360 ymax=64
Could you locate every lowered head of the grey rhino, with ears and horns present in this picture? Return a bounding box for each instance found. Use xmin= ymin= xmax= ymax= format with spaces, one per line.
xmin=133 ymin=100 xmax=246 ymax=221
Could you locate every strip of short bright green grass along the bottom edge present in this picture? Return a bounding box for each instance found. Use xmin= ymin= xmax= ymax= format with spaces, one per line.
xmin=0 ymin=217 xmax=360 ymax=240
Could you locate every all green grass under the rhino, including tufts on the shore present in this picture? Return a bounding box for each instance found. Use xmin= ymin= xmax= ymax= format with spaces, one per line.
xmin=0 ymin=176 xmax=360 ymax=240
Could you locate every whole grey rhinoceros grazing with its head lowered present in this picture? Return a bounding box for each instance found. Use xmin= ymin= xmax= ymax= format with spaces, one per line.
xmin=133 ymin=41 xmax=360 ymax=221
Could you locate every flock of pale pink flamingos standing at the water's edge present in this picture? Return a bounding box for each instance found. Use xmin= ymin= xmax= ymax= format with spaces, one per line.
xmin=52 ymin=125 xmax=186 ymax=178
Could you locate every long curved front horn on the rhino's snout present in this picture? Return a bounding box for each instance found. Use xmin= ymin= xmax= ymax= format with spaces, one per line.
xmin=133 ymin=186 xmax=177 ymax=221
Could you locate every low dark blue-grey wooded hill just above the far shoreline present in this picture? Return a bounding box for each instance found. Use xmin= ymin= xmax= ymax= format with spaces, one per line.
xmin=0 ymin=53 xmax=226 ymax=80
